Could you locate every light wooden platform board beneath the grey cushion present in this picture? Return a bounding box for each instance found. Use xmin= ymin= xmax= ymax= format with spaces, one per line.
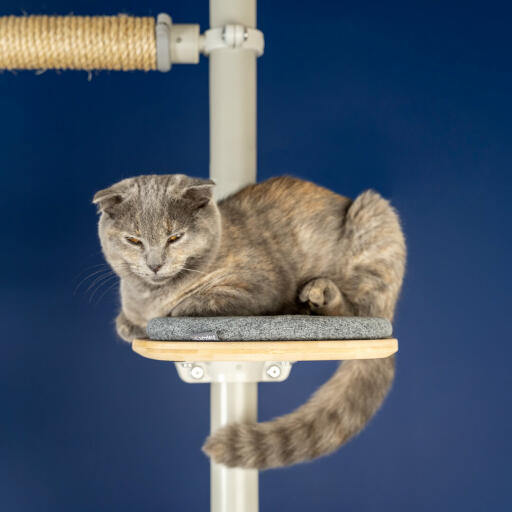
xmin=132 ymin=338 xmax=398 ymax=361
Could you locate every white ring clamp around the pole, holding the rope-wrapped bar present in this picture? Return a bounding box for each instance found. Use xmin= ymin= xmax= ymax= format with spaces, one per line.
xmin=202 ymin=25 xmax=265 ymax=57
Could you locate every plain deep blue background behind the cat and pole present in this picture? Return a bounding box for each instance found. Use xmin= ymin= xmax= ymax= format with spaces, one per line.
xmin=0 ymin=0 xmax=512 ymax=512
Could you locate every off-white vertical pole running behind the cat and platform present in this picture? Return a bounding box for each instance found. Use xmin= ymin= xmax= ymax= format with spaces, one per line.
xmin=209 ymin=0 xmax=258 ymax=512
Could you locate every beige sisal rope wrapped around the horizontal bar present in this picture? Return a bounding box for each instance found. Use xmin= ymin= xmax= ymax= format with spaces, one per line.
xmin=0 ymin=15 xmax=156 ymax=71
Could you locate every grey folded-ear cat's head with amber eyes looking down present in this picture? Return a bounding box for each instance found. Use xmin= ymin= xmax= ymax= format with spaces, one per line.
xmin=93 ymin=174 xmax=221 ymax=285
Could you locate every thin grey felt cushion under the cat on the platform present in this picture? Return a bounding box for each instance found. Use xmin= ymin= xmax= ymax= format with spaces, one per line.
xmin=146 ymin=315 xmax=392 ymax=341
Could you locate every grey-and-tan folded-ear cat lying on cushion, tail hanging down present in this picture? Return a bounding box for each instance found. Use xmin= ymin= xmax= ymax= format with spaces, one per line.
xmin=93 ymin=174 xmax=406 ymax=470
